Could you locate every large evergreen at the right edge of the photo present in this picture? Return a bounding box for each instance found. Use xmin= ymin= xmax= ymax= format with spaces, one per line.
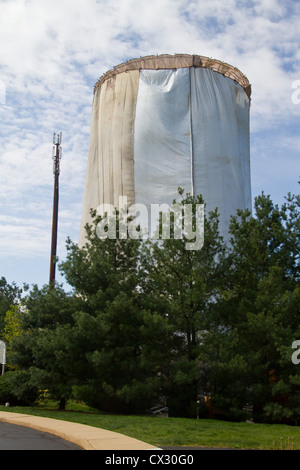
xmin=207 ymin=190 xmax=300 ymax=420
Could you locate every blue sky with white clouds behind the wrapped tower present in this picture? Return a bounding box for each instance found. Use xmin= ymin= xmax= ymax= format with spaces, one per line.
xmin=0 ymin=0 xmax=300 ymax=287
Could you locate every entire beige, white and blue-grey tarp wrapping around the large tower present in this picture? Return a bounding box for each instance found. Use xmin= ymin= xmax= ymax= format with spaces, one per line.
xmin=79 ymin=60 xmax=251 ymax=245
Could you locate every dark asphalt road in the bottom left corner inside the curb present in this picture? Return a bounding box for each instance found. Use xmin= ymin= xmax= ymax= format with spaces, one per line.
xmin=0 ymin=422 xmax=80 ymax=450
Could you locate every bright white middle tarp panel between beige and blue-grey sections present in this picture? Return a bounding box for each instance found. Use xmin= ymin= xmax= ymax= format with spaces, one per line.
xmin=134 ymin=69 xmax=192 ymax=205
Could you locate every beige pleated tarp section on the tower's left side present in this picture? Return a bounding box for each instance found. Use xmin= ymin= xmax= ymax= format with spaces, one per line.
xmin=79 ymin=70 xmax=139 ymax=246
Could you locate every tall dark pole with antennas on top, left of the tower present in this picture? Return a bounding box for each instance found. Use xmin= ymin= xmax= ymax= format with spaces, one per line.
xmin=49 ymin=132 xmax=62 ymax=288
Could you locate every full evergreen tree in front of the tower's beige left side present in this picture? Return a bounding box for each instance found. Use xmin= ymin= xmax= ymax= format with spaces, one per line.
xmin=61 ymin=209 xmax=168 ymax=412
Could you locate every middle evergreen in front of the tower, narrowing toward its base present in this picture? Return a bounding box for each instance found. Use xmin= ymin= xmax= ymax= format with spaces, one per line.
xmin=140 ymin=192 xmax=226 ymax=417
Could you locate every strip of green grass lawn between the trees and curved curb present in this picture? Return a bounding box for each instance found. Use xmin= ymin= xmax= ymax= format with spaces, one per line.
xmin=0 ymin=404 xmax=300 ymax=450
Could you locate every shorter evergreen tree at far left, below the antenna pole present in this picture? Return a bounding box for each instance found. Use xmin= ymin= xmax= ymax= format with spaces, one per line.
xmin=10 ymin=285 xmax=77 ymax=409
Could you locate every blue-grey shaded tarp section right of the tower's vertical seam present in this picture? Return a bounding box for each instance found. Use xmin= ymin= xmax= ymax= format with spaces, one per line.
xmin=190 ymin=68 xmax=251 ymax=237
